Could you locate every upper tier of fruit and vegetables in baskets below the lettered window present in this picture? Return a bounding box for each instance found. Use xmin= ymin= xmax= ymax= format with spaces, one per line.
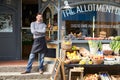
xmin=61 ymin=37 xmax=120 ymax=65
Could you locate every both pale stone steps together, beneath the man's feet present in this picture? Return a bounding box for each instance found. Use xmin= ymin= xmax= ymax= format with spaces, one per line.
xmin=0 ymin=57 xmax=54 ymax=80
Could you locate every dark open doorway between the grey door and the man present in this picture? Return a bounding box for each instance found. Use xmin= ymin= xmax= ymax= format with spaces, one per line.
xmin=22 ymin=0 xmax=38 ymax=59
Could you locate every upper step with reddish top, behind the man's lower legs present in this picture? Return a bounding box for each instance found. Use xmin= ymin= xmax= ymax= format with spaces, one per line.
xmin=0 ymin=60 xmax=54 ymax=72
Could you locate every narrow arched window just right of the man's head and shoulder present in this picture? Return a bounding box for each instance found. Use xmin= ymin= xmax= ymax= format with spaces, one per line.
xmin=43 ymin=4 xmax=58 ymax=41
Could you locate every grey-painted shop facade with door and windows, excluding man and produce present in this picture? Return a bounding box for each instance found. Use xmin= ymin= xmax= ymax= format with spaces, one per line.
xmin=0 ymin=0 xmax=120 ymax=60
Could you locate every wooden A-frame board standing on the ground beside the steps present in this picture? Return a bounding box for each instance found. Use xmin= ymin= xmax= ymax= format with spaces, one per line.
xmin=50 ymin=59 xmax=66 ymax=80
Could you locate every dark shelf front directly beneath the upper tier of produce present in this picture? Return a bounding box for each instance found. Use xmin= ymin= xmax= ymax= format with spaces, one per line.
xmin=64 ymin=64 xmax=120 ymax=75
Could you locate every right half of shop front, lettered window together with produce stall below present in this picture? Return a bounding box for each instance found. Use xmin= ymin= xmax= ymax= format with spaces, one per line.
xmin=51 ymin=0 xmax=120 ymax=80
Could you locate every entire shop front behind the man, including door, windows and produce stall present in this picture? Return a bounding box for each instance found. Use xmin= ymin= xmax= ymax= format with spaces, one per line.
xmin=0 ymin=0 xmax=120 ymax=80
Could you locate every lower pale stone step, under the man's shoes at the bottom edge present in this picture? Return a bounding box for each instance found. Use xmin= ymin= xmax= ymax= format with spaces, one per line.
xmin=0 ymin=72 xmax=51 ymax=80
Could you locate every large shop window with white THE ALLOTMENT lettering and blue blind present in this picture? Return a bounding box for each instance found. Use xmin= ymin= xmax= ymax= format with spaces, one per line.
xmin=60 ymin=0 xmax=120 ymax=50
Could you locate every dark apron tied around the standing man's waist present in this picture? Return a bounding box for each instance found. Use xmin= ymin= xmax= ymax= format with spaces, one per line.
xmin=31 ymin=37 xmax=48 ymax=54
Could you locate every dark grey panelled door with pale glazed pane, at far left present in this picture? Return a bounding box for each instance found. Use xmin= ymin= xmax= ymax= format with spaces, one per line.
xmin=0 ymin=0 xmax=21 ymax=60
